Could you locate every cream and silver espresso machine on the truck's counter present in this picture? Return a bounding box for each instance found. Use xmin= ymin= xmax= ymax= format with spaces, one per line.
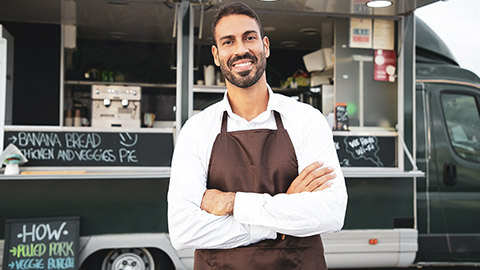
xmin=92 ymin=85 xmax=141 ymax=128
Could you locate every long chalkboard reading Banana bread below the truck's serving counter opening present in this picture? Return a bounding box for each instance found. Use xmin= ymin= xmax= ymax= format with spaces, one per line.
xmin=4 ymin=131 xmax=173 ymax=166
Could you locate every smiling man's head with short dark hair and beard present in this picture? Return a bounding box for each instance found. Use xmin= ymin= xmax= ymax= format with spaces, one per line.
xmin=212 ymin=15 xmax=270 ymax=88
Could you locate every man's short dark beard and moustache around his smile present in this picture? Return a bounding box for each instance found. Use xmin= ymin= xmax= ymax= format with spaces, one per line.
xmin=220 ymin=52 xmax=267 ymax=88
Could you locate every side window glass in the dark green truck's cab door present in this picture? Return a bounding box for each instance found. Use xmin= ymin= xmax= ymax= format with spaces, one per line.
xmin=441 ymin=94 xmax=480 ymax=162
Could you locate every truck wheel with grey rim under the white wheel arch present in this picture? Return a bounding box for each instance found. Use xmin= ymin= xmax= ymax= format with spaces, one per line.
xmin=102 ymin=248 xmax=155 ymax=270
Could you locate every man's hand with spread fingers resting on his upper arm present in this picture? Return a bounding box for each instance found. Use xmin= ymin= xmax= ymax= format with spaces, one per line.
xmin=287 ymin=162 xmax=335 ymax=194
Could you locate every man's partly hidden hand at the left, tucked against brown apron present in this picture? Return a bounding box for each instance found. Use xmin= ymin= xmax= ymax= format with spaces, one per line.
xmin=200 ymin=189 xmax=235 ymax=216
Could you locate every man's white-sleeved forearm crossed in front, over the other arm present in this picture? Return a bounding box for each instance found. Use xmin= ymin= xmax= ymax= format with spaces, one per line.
xmin=234 ymin=185 xmax=347 ymax=237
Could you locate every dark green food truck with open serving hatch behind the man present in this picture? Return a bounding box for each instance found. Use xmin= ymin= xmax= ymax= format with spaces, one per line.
xmin=0 ymin=0 xmax=480 ymax=270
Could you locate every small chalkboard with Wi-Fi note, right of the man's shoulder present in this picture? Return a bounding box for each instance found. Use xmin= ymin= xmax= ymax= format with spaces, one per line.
xmin=333 ymin=136 xmax=397 ymax=167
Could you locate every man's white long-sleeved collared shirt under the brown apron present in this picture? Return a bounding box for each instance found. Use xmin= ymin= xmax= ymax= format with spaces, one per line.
xmin=168 ymin=87 xmax=347 ymax=249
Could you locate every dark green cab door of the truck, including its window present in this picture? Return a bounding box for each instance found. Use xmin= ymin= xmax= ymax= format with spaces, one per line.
xmin=429 ymin=84 xmax=480 ymax=261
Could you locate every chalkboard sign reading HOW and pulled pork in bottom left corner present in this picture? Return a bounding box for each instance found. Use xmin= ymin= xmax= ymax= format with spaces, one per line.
xmin=3 ymin=217 xmax=80 ymax=270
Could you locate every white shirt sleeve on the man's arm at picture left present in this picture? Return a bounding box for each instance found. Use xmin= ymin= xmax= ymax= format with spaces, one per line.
xmin=168 ymin=119 xmax=276 ymax=249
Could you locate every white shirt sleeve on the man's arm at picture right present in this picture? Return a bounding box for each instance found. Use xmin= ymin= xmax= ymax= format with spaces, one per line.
xmin=233 ymin=107 xmax=348 ymax=237
